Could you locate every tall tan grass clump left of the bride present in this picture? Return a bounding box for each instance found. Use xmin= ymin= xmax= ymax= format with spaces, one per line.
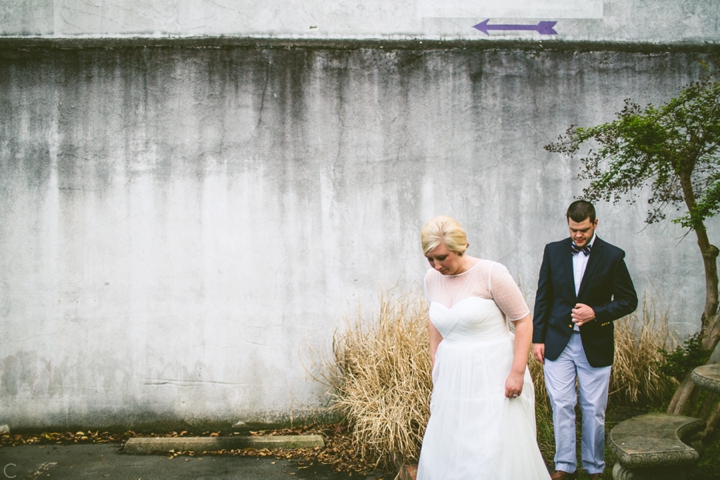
xmin=322 ymin=292 xmax=432 ymax=467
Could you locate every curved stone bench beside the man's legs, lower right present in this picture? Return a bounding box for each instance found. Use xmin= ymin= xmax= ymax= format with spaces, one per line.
xmin=609 ymin=413 xmax=705 ymax=480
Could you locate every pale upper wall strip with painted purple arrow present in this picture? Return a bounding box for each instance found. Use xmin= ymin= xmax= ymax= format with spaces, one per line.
xmin=0 ymin=0 xmax=720 ymax=44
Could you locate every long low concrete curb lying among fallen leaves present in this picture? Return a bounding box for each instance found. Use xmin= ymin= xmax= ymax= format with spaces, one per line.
xmin=123 ymin=435 xmax=325 ymax=455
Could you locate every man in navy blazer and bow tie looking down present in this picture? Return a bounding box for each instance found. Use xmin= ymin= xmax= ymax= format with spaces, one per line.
xmin=533 ymin=200 xmax=638 ymax=480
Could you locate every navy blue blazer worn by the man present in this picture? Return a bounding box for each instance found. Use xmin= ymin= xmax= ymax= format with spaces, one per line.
xmin=533 ymin=236 xmax=638 ymax=367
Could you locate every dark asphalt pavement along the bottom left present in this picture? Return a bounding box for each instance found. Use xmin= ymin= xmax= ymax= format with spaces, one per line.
xmin=0 ymin=444 xmax=394 ymax=480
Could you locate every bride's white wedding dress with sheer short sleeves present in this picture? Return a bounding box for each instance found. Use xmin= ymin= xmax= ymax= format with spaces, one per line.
xmin=417 ymin=260 xmax=550 ymax=480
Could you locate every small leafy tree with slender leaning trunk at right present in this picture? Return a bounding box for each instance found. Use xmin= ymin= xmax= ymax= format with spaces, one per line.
xmin=545 ymin=76 xmax=720 ymax=413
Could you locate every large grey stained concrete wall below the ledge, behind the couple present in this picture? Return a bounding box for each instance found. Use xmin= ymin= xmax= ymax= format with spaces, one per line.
xmin=0 ymin=43 xmax=720 ymax=428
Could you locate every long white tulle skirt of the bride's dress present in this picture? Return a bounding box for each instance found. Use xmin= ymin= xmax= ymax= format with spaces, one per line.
xmin=417 ymin=335 xmax=550 ymax=480
